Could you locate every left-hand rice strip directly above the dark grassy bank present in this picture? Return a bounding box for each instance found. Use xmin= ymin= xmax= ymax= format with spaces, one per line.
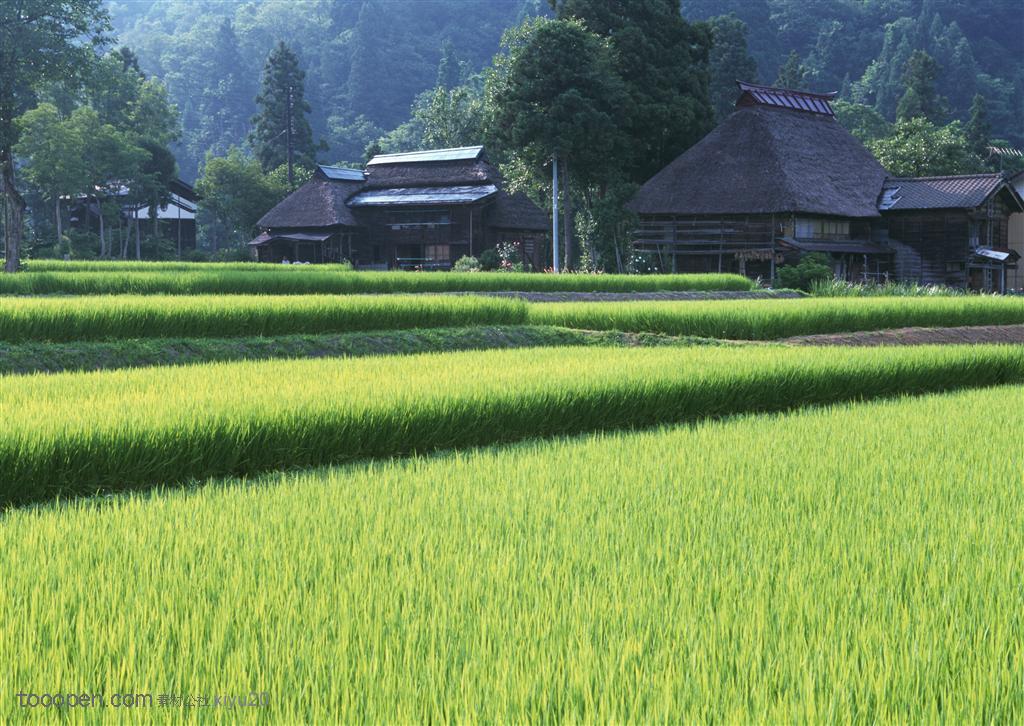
xmin=0 ymin=295 xmax=526 ymax=342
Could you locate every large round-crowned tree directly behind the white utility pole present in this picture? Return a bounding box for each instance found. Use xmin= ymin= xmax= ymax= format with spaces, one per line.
xmin=486 ymin=19 xmax=628 ymax=268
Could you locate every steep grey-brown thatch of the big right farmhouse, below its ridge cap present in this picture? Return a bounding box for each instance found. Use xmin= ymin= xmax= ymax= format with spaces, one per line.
xmin=630 ymin=104 xmax=886 ymax=217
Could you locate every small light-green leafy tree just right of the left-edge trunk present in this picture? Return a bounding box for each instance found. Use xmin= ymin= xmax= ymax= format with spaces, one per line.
xmin=14 ymin=103 xmax=88 ymax=244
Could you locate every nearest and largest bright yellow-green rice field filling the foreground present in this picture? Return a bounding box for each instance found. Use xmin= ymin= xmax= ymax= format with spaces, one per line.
xmin=0 ymin=388 xmax=1024 ymax=723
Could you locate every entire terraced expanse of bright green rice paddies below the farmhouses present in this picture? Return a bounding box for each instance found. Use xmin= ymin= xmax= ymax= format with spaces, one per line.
xmin=0 ymin=261 xmax=1024 ymax=724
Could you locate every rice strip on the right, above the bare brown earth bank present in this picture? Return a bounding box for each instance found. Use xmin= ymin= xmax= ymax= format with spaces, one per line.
xmin=529 ymin=296 xmax=1024 ymax=340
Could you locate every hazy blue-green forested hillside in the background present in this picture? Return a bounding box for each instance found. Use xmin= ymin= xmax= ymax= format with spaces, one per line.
xmin=109 ymin=0 xmax=1024 ymax=178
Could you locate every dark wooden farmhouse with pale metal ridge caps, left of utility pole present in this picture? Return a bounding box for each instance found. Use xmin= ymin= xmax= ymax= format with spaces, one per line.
xmin=249 ymin=146 xmax=550 ymax=269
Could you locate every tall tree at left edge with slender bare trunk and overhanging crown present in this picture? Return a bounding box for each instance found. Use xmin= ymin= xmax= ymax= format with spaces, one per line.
xmin=0 ymin=0 xmax=110 ymax=272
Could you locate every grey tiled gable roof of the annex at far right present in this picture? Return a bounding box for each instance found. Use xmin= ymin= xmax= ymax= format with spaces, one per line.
xmin=879 ymin=174 xmax=1020 ymax=211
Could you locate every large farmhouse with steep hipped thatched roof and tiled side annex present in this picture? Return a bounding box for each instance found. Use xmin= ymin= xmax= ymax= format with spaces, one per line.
xmin=630 ymin=82 xmax=1024 ymax=291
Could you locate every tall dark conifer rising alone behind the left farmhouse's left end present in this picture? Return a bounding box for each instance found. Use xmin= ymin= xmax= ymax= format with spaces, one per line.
xmin=249 ymin=42 xmax=316 ymax=171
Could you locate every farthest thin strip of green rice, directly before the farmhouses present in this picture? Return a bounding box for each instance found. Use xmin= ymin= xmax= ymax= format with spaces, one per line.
xmin=0 ymin=263 xmax=754 ymax=295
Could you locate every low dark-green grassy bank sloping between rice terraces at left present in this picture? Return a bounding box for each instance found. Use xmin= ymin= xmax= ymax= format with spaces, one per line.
xmin=0 ymin=326 xmax=725 ymax=374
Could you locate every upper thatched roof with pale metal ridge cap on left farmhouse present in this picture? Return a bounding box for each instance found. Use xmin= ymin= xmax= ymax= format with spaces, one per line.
xmin=367 ymin=146 xmax=501 ymax=188
